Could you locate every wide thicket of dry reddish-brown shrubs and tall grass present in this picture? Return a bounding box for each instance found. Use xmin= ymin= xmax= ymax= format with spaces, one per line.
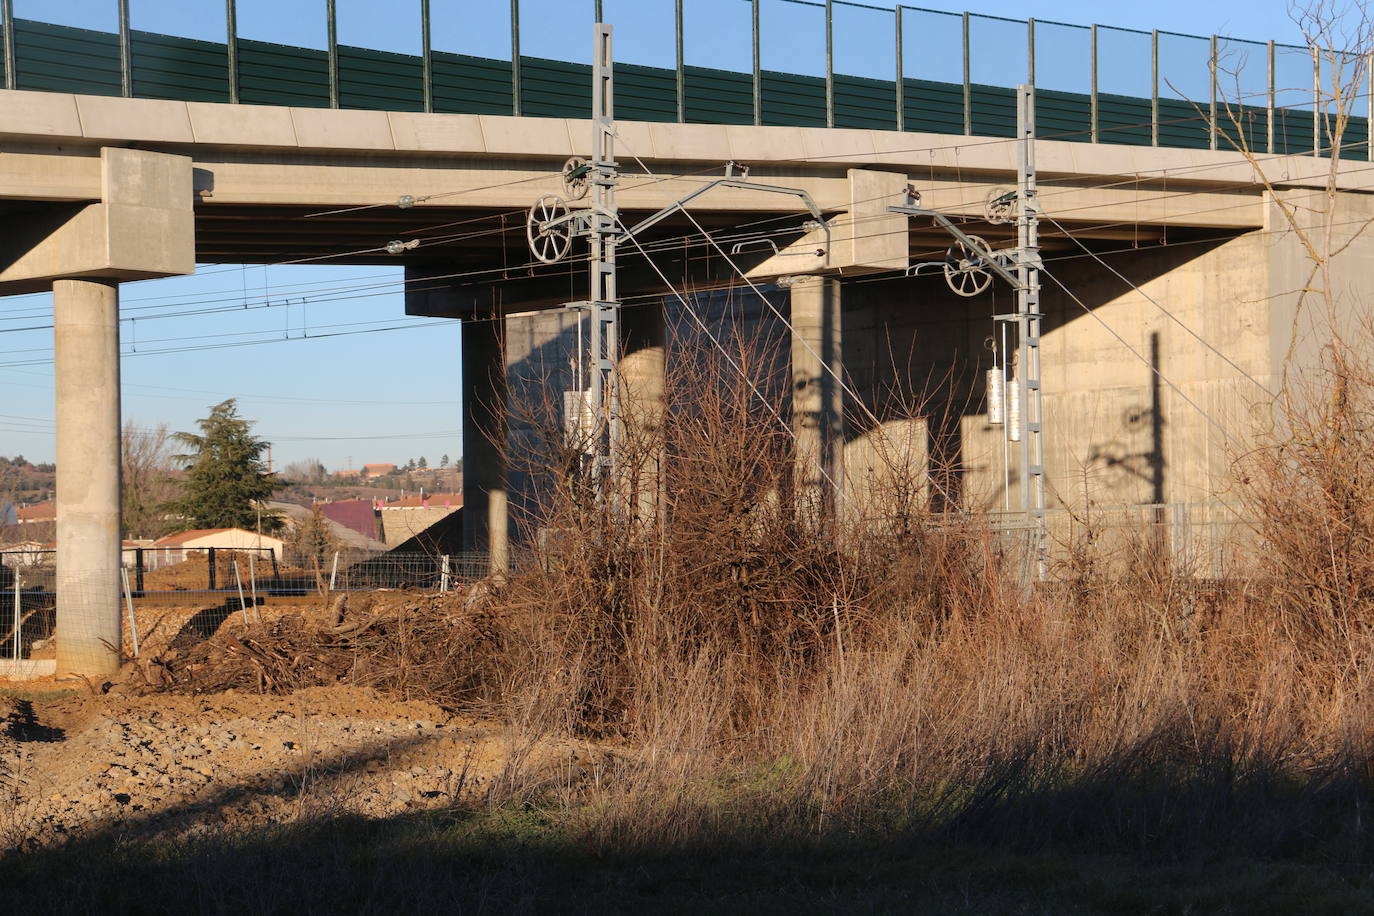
xmin=475 ymin=330 xmax=1374 ymax=860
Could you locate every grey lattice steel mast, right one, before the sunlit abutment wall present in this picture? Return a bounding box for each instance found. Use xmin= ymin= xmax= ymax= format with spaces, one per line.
xmin=1015 ymin=85 xmax=1048 ymax=581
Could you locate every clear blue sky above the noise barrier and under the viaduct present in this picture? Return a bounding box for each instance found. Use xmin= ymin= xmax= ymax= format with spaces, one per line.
xmin=0 ymin=0 xmax=1319 ymax=468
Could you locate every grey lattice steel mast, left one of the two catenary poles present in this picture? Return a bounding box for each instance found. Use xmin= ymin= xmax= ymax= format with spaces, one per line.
xmin=588 ymin=22 xmax=620 ymax=486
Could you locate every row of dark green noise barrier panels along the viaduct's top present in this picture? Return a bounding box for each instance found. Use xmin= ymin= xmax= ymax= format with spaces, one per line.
xmin=0 ymin=19 xmax=1369 ymax=161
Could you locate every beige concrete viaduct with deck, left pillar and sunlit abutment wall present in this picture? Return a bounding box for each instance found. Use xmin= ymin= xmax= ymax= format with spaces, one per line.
xmin=0 ymin=82 xmax=1374 ymax=676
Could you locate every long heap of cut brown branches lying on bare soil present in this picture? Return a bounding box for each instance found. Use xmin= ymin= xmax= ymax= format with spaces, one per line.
xmin=144 ymin=595 xmax=502 ymax=709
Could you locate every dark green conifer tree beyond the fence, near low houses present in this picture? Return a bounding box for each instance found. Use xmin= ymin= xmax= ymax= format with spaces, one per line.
xmin=168 ymin=398 xmax=282 ymax=531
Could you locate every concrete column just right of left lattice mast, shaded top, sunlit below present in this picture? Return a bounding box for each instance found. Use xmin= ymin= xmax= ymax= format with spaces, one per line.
xmin=618 ymin=301 xmax=665 ymax=522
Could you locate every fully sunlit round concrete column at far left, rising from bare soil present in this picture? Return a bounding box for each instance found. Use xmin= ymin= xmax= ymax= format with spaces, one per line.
xmin=52 ymin=280 xmax=122 ymax=677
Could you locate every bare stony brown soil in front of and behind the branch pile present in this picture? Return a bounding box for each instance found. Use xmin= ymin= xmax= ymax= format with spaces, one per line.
xmin=0 ymin=596 xmax=605 ymax=857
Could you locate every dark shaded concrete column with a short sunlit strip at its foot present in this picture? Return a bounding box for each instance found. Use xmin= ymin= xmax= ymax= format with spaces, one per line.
xmin=462 ymin=313 xmax=510 ymax=574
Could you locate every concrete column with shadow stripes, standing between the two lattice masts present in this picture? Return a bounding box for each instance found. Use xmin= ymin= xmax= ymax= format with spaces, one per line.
xmin=791 ymin=276 xmax=845 ymax=514
